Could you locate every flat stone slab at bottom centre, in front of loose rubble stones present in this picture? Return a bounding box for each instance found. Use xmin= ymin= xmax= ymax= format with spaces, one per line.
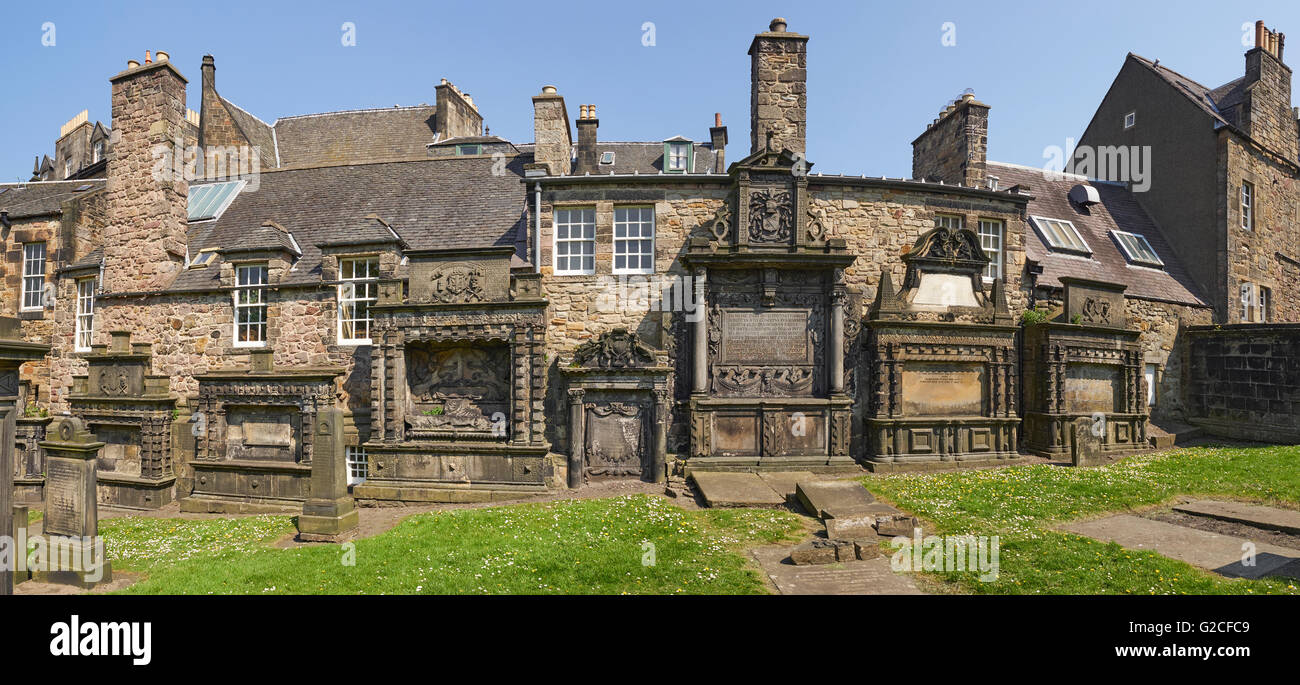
xmin=751 ymin=546 xmax=923 ymax=594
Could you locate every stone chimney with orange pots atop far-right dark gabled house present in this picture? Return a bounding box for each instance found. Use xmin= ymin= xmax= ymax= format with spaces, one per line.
xmin=1239 ymin=21 xmax=1300 ymax=160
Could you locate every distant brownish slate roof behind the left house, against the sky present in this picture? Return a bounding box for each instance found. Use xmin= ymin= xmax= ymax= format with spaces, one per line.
xmin=273 ymin=105 xmax=437 ymax=168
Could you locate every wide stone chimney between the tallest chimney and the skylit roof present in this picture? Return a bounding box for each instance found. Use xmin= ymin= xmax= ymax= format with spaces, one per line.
xmin=911 ymin=92 xmax=988 ymax=187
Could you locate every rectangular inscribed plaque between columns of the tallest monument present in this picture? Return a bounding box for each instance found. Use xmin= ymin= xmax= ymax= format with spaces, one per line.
xmin=722 ymin=309 xmax=813 ymax=364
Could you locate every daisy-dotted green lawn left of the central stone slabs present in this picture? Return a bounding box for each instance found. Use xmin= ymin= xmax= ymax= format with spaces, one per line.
xmin=109 ymin=495 xmax=802 ymax=594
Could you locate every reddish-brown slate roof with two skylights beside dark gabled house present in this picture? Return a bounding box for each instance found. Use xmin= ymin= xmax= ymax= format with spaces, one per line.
xmin=988 ymin=161 xmax=1206 ymax=305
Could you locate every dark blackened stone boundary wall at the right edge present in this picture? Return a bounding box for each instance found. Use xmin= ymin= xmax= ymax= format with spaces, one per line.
xmin=1187 ymin=324 xmax=1300 ymax=445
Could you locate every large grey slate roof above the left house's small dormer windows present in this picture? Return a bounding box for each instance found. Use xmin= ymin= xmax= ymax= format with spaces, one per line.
xmin=170 ymin=157 xmax=525 ymax=290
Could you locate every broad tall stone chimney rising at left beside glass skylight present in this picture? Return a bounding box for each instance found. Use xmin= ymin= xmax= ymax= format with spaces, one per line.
xmin=103 ymin=53 xmax=190 ymax=292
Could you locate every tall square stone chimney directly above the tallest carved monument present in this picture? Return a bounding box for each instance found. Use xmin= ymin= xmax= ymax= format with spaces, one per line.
xmin=749 ymin=17 xmax=809 ymax=153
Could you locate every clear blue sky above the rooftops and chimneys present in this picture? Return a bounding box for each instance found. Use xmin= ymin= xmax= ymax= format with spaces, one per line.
xmin=0 ymin=0 xmax=1300 ymax=182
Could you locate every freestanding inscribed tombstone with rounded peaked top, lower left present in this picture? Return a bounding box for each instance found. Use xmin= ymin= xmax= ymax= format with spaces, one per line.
xmin=31 ymin=417 xmax=113 ymax=588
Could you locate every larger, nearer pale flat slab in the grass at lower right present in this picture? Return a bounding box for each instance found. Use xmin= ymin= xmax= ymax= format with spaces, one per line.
xmin=1061 ymin=513 xmax=1300 ymax=578
